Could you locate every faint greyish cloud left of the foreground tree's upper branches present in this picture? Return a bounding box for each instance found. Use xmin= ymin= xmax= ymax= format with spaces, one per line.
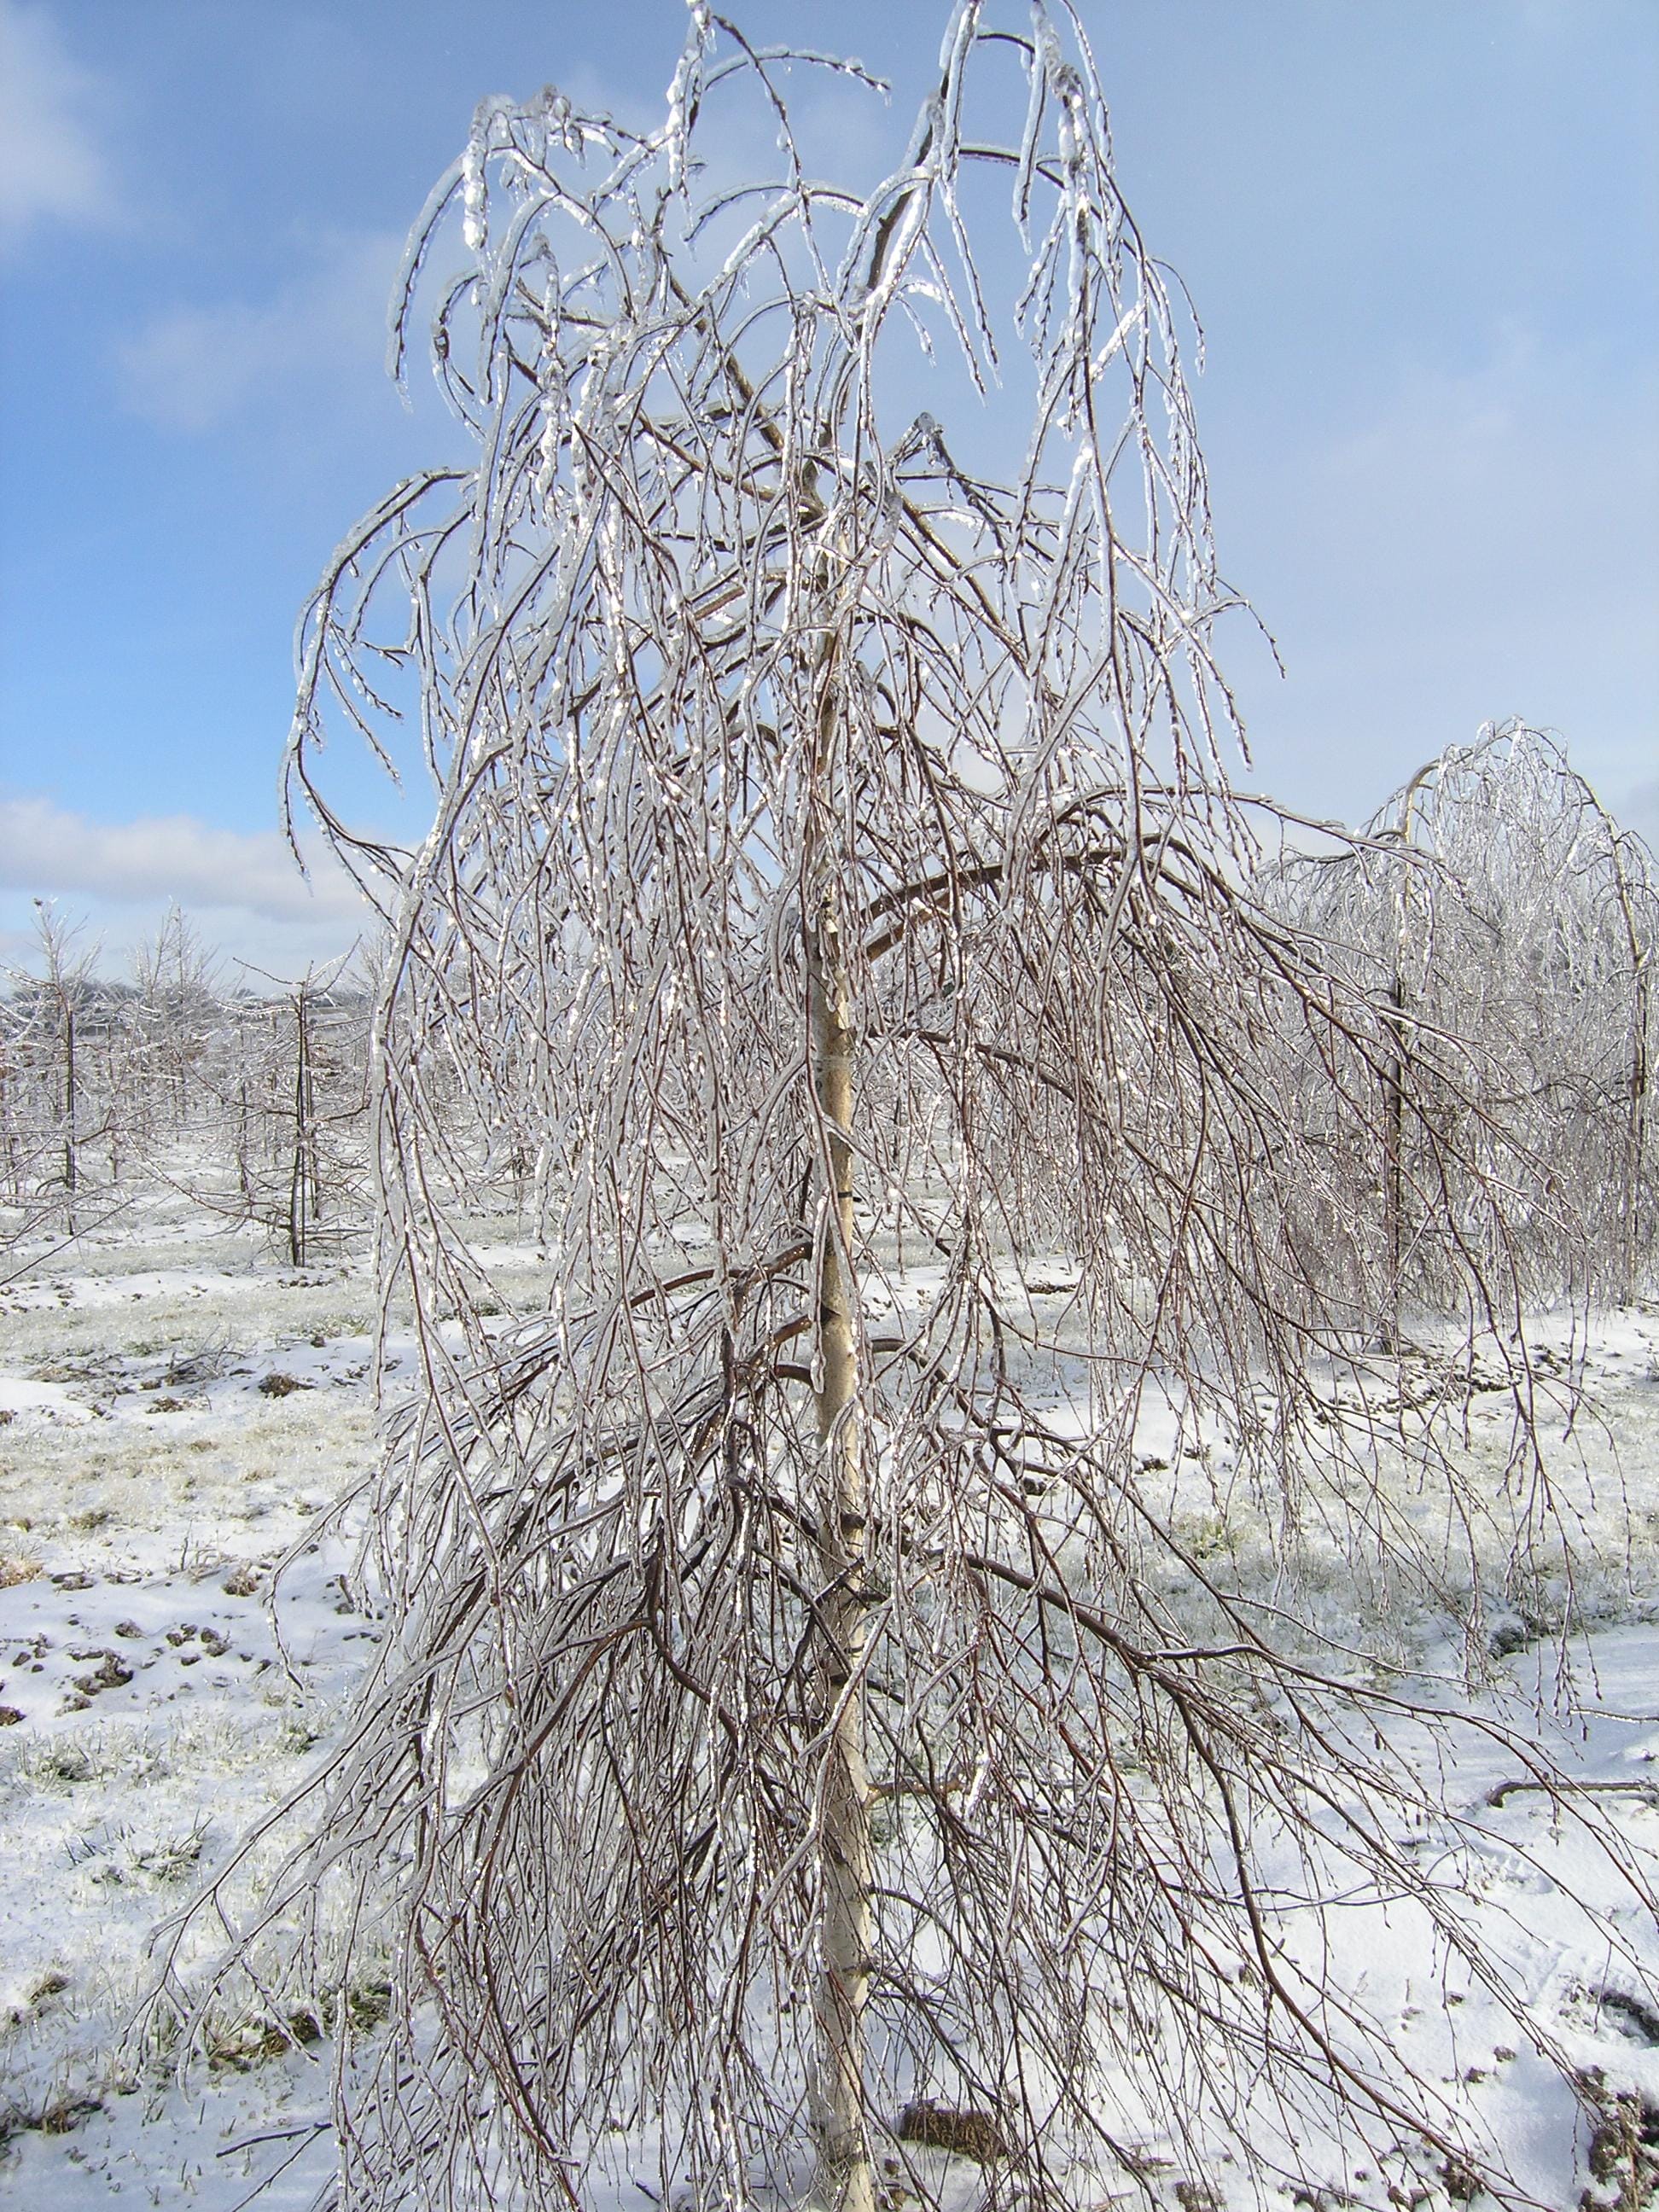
xmin=119 ymin=230 xmax=403 ymax=434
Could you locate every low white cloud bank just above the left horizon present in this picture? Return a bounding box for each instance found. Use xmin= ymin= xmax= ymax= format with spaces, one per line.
xmin=0 ymin=799 xmax=367 ymax=942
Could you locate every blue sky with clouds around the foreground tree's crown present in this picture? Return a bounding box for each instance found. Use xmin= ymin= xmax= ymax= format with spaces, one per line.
xmin=0 ymin=0 xmax=1659 ymax=967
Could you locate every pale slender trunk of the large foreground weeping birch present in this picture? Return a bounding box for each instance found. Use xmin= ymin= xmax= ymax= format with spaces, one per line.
xmin=807 ymin=903 xmax=876 ymax=2212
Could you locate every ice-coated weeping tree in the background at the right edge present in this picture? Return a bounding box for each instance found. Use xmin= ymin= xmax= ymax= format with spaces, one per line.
xmin=1266 ymin=724 xmax=1659 ymax=1331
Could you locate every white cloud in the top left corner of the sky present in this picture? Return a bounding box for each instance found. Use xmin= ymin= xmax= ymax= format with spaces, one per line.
xmin=0 ymin=0 xmax=113 ymax=250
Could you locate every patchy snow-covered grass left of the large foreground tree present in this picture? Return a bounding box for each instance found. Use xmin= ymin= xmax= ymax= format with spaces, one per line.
xmin=0 ymin=1208 xmax=376 ymax=2205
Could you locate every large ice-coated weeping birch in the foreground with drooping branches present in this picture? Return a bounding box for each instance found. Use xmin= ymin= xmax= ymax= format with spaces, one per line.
xmin=152 ymin=0 xmax=1654 ymax=2212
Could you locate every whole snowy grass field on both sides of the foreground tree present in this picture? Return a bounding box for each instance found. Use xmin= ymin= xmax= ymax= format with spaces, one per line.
xmin=0 ymin=1206 xmax=1659 ymax=2212
